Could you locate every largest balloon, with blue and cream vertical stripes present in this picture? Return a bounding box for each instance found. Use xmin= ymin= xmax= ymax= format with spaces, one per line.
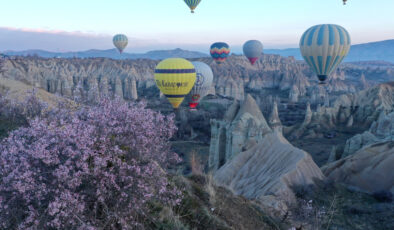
xmin=300 ymin=24 xmax=350 ymax=84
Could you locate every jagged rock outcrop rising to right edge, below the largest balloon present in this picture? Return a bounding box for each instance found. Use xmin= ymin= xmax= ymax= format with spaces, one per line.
xmin=286 ymin=82 xmax=394 ymax=139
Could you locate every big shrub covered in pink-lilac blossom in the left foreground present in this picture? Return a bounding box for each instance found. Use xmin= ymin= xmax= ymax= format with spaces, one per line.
xmin=0 ymin=96 xmax=180 ymax=229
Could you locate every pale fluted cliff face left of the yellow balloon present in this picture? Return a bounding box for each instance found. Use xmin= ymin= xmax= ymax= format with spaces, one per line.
xmin=0 ymin=58 xmax=157 ymax=100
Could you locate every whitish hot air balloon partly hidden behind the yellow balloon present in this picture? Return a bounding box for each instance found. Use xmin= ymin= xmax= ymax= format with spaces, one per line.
xmin=189 ymin=61 xmax=213 ymax=109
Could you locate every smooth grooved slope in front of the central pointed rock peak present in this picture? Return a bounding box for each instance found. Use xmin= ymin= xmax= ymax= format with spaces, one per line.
xmin=214 ymin=131 xmax=324 ymax=202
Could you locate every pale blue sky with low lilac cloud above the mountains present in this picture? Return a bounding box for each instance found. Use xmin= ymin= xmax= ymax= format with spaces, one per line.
xmin=0 ymin=0 xmax=394 ymax=52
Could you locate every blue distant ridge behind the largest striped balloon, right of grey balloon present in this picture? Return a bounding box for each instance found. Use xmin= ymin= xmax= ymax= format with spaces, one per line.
xmin=264 ymin=39 xmax=394 ymax=63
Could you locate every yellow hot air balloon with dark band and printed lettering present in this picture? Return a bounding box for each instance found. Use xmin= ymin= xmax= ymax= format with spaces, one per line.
xmin=155 ymin=58 xmax=196 ymax=109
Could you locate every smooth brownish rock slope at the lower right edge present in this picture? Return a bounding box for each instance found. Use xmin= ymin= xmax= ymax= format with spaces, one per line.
xmin=323 ymin=141 xmax=394 ymax=194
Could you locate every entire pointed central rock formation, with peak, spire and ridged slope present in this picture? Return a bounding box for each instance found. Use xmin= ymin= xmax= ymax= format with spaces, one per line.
xmin=209 ymin=95 xmax=324 ymax=204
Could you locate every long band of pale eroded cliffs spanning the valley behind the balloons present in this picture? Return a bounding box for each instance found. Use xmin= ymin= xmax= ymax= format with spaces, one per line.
xmin=0 ymin=55 xmax=394 ymax=104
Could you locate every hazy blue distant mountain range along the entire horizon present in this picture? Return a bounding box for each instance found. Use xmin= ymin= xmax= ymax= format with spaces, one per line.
xmin=3 ymin=39 xmax=394 ymax=63
